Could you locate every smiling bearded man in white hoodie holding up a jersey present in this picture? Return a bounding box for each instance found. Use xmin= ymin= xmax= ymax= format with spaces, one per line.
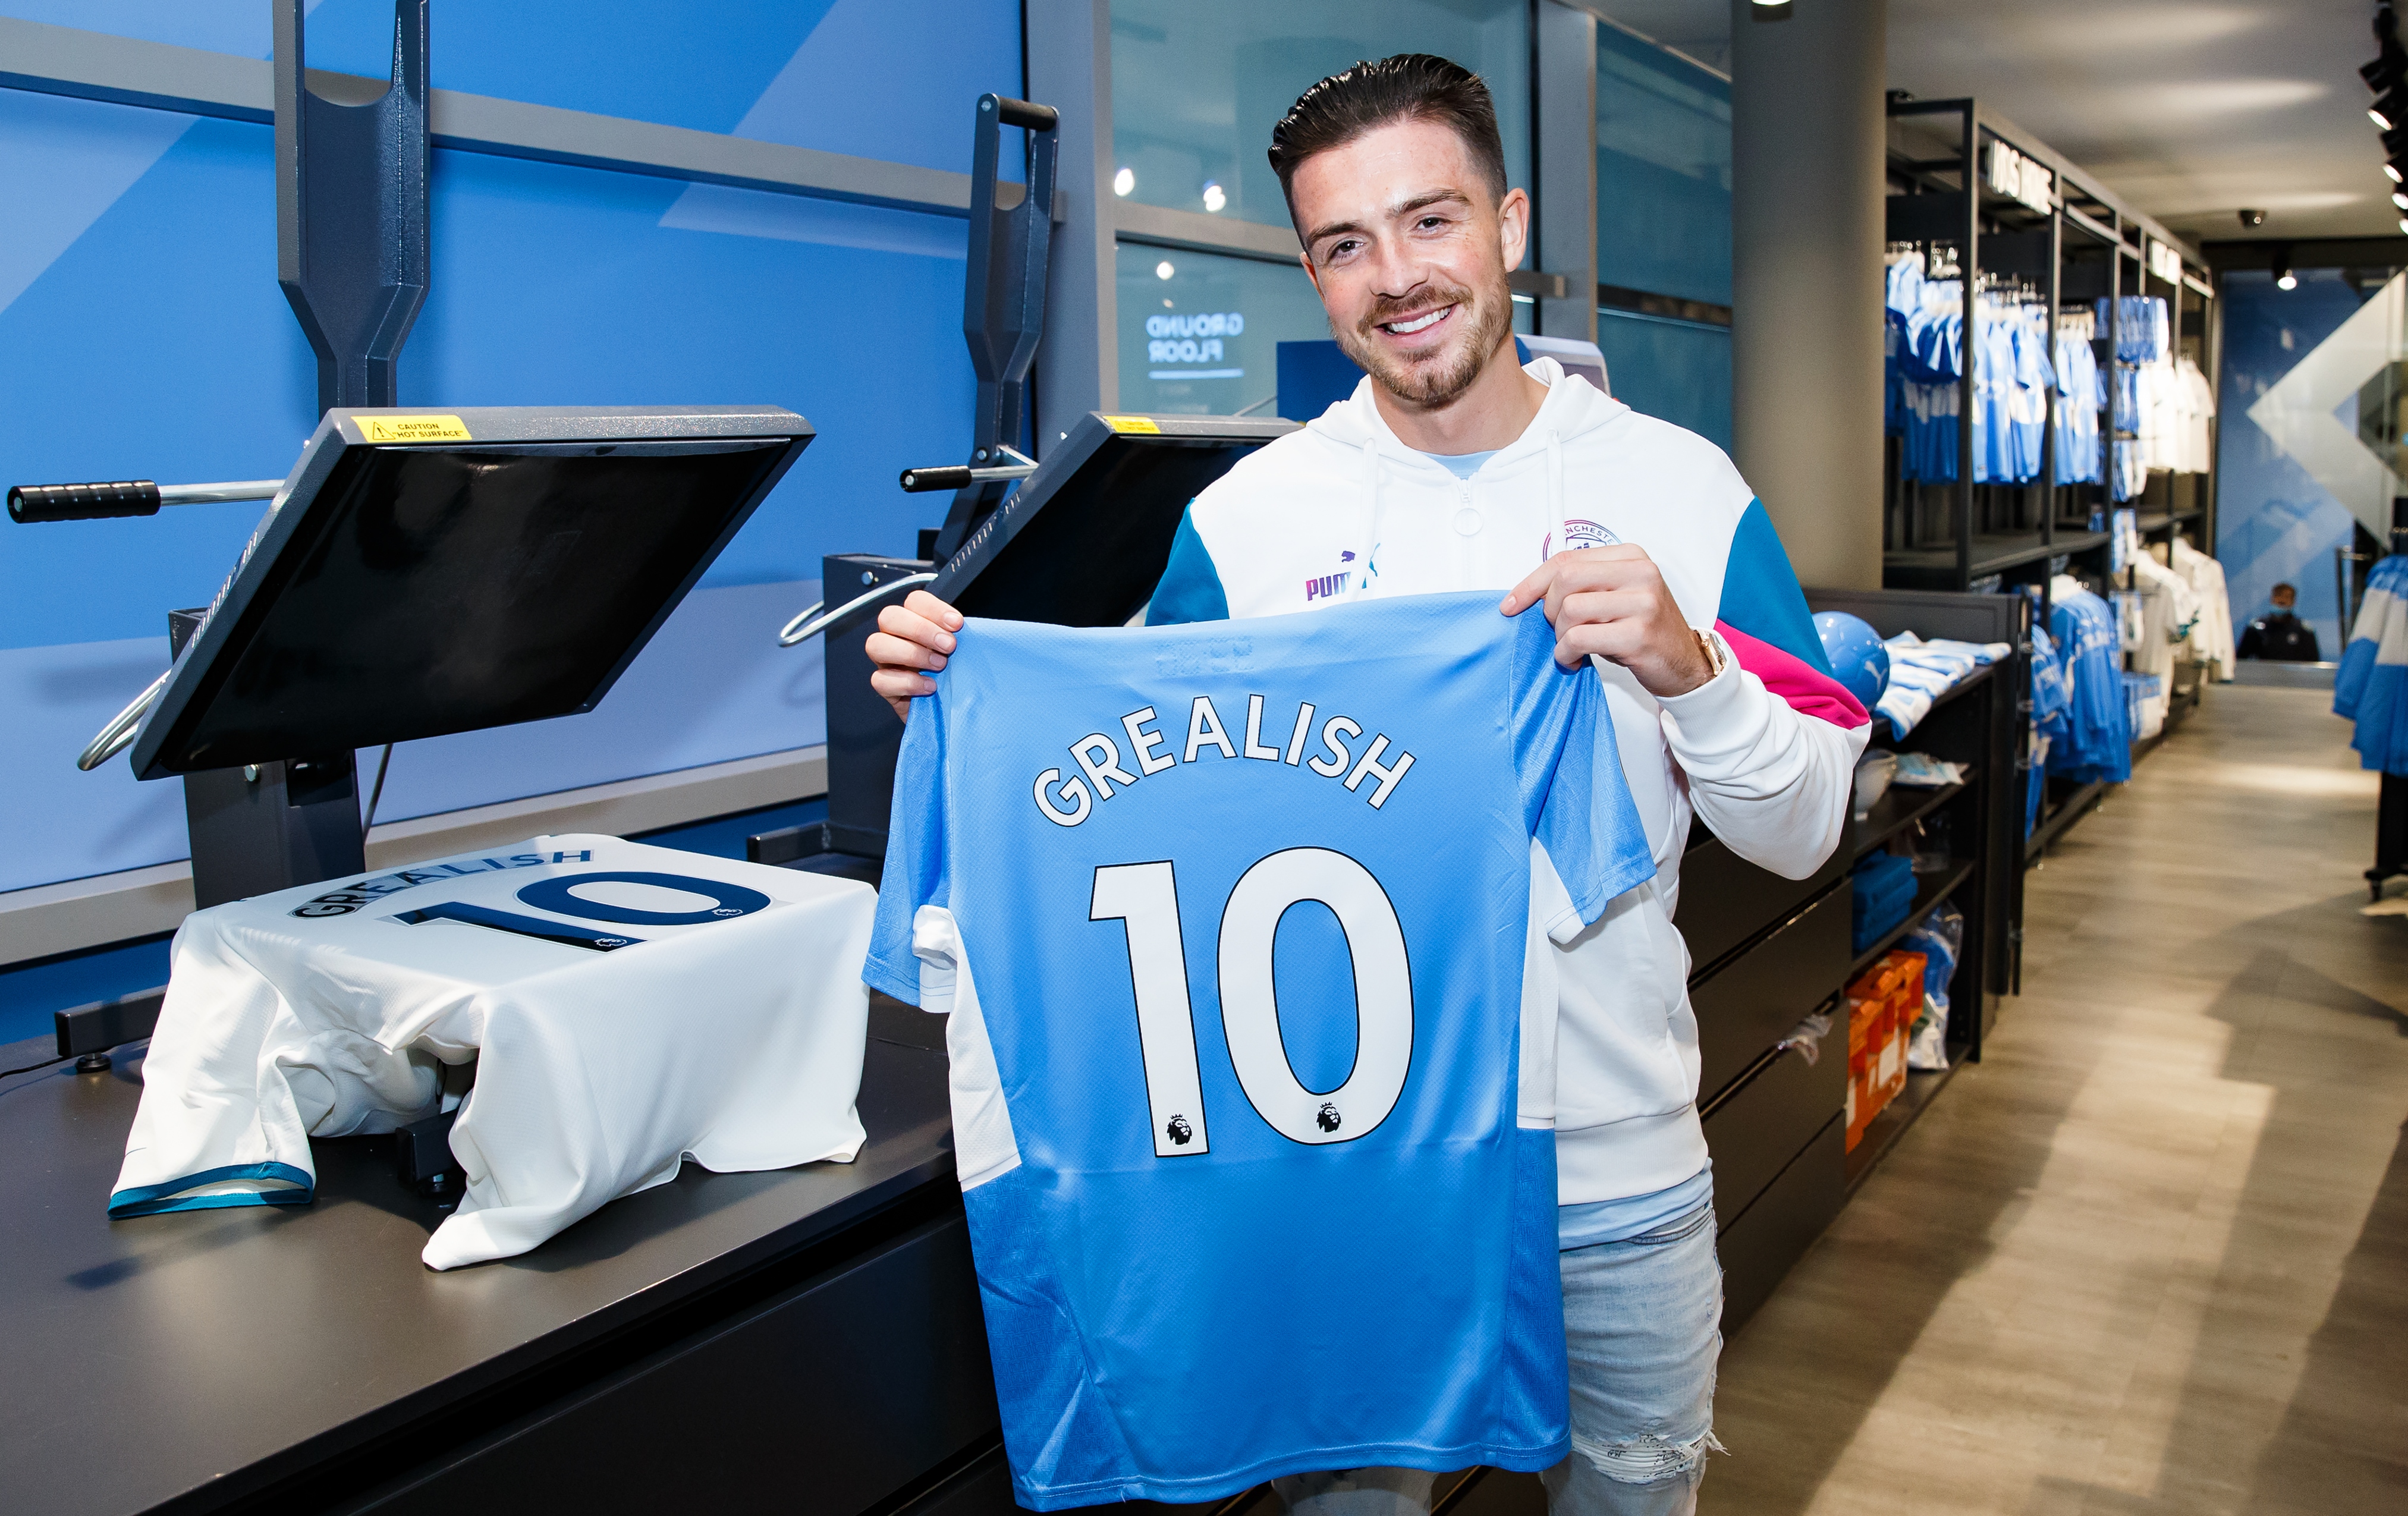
xmin=869 ymin=53 xmax=1866 ymax=1516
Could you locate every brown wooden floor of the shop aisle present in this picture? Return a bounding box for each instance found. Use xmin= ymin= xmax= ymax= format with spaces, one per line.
xmin=1700 ymin=686 xmax=2408 ymax=1516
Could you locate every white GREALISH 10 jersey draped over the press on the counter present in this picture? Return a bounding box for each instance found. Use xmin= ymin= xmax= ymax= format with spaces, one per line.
xmin=108 ymin=835 xmax=876 ymax=1268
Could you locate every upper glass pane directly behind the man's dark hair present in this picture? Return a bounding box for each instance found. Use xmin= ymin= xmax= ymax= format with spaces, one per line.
xmin=1112 ymin=0 xmax=1521 ymax=234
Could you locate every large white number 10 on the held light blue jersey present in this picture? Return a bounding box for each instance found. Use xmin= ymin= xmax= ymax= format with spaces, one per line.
xmin=1089 ymin=847 xmax=1413 ymax=1158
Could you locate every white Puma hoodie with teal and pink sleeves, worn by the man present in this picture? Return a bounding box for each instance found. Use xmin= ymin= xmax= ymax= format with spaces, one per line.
xmin=1146 ymin=358 xmax=1866 ymax=1206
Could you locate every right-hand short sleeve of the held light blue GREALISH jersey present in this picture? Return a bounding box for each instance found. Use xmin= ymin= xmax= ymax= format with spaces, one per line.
xmin=1510 ymin=611 xmax=1654 ymax=941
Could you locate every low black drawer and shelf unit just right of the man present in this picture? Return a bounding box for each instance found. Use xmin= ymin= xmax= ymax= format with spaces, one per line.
xmin=1676 ymin=590 xmax=2030 ymax=1331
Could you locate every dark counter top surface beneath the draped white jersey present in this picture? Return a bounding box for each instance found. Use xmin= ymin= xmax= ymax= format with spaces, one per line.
xmin=0 ymin=1006 xmax=954 ymax=1516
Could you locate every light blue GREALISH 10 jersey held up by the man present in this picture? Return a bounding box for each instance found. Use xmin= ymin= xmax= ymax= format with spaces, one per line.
xmin=865 ymin=592 xmax=1654 ymax=1511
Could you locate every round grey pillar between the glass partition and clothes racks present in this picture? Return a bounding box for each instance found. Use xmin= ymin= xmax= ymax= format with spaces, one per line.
xmin=1731 ymin=0 xmax=1888 ymax=590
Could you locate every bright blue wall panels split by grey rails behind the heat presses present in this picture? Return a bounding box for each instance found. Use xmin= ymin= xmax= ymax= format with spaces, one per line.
xmin=0 ymin=0 xmax=1021 ymax=891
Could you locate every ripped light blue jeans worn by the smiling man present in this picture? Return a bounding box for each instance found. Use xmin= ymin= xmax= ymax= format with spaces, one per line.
xmin=1274 ymin=1203 xmax=1722 ymax=1516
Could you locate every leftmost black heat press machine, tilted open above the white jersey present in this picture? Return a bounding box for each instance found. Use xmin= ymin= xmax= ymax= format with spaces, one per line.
xmin=7 ymin=0 xmax=812 ymax=1087
